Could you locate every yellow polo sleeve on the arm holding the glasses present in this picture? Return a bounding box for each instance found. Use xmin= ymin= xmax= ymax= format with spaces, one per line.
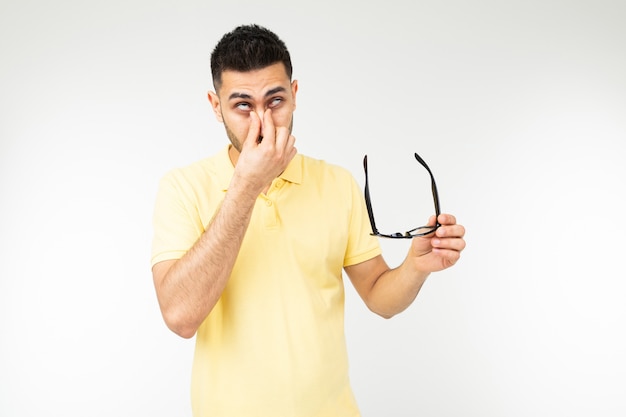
xmin=343 ymin=176 xmax=382 ymax=267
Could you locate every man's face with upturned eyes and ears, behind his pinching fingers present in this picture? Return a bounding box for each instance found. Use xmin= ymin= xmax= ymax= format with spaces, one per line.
xmin=209 ymin=62 xmax=298 ymax=153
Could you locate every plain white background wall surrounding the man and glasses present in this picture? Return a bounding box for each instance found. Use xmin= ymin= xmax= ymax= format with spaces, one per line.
xmin=0 ymin=0 xmax=626 ymax=417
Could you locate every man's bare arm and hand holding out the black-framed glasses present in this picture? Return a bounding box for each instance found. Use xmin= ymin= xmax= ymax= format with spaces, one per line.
xmin=345 ymin=214 xmax=465 ymax=318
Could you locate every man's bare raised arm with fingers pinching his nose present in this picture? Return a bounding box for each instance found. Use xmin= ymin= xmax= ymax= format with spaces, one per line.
xmin=152 ymin=111 xmax=296 ymax=338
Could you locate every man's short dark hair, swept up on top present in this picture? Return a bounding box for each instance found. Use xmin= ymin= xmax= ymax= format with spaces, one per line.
xmin=211 ymin=25 xmax=293 ymax=90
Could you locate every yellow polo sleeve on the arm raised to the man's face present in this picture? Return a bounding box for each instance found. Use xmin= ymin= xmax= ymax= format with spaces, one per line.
xmin=151 ymin=171 xmax=204 ymax=266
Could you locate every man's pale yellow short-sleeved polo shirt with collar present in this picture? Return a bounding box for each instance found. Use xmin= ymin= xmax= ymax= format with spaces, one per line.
xmin=152 ymin=148 xmax=381 ymax=417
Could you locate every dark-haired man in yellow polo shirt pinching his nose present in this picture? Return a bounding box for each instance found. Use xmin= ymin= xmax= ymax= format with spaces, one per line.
xmin=152 ymin=25 xmax=465 ymax=417
